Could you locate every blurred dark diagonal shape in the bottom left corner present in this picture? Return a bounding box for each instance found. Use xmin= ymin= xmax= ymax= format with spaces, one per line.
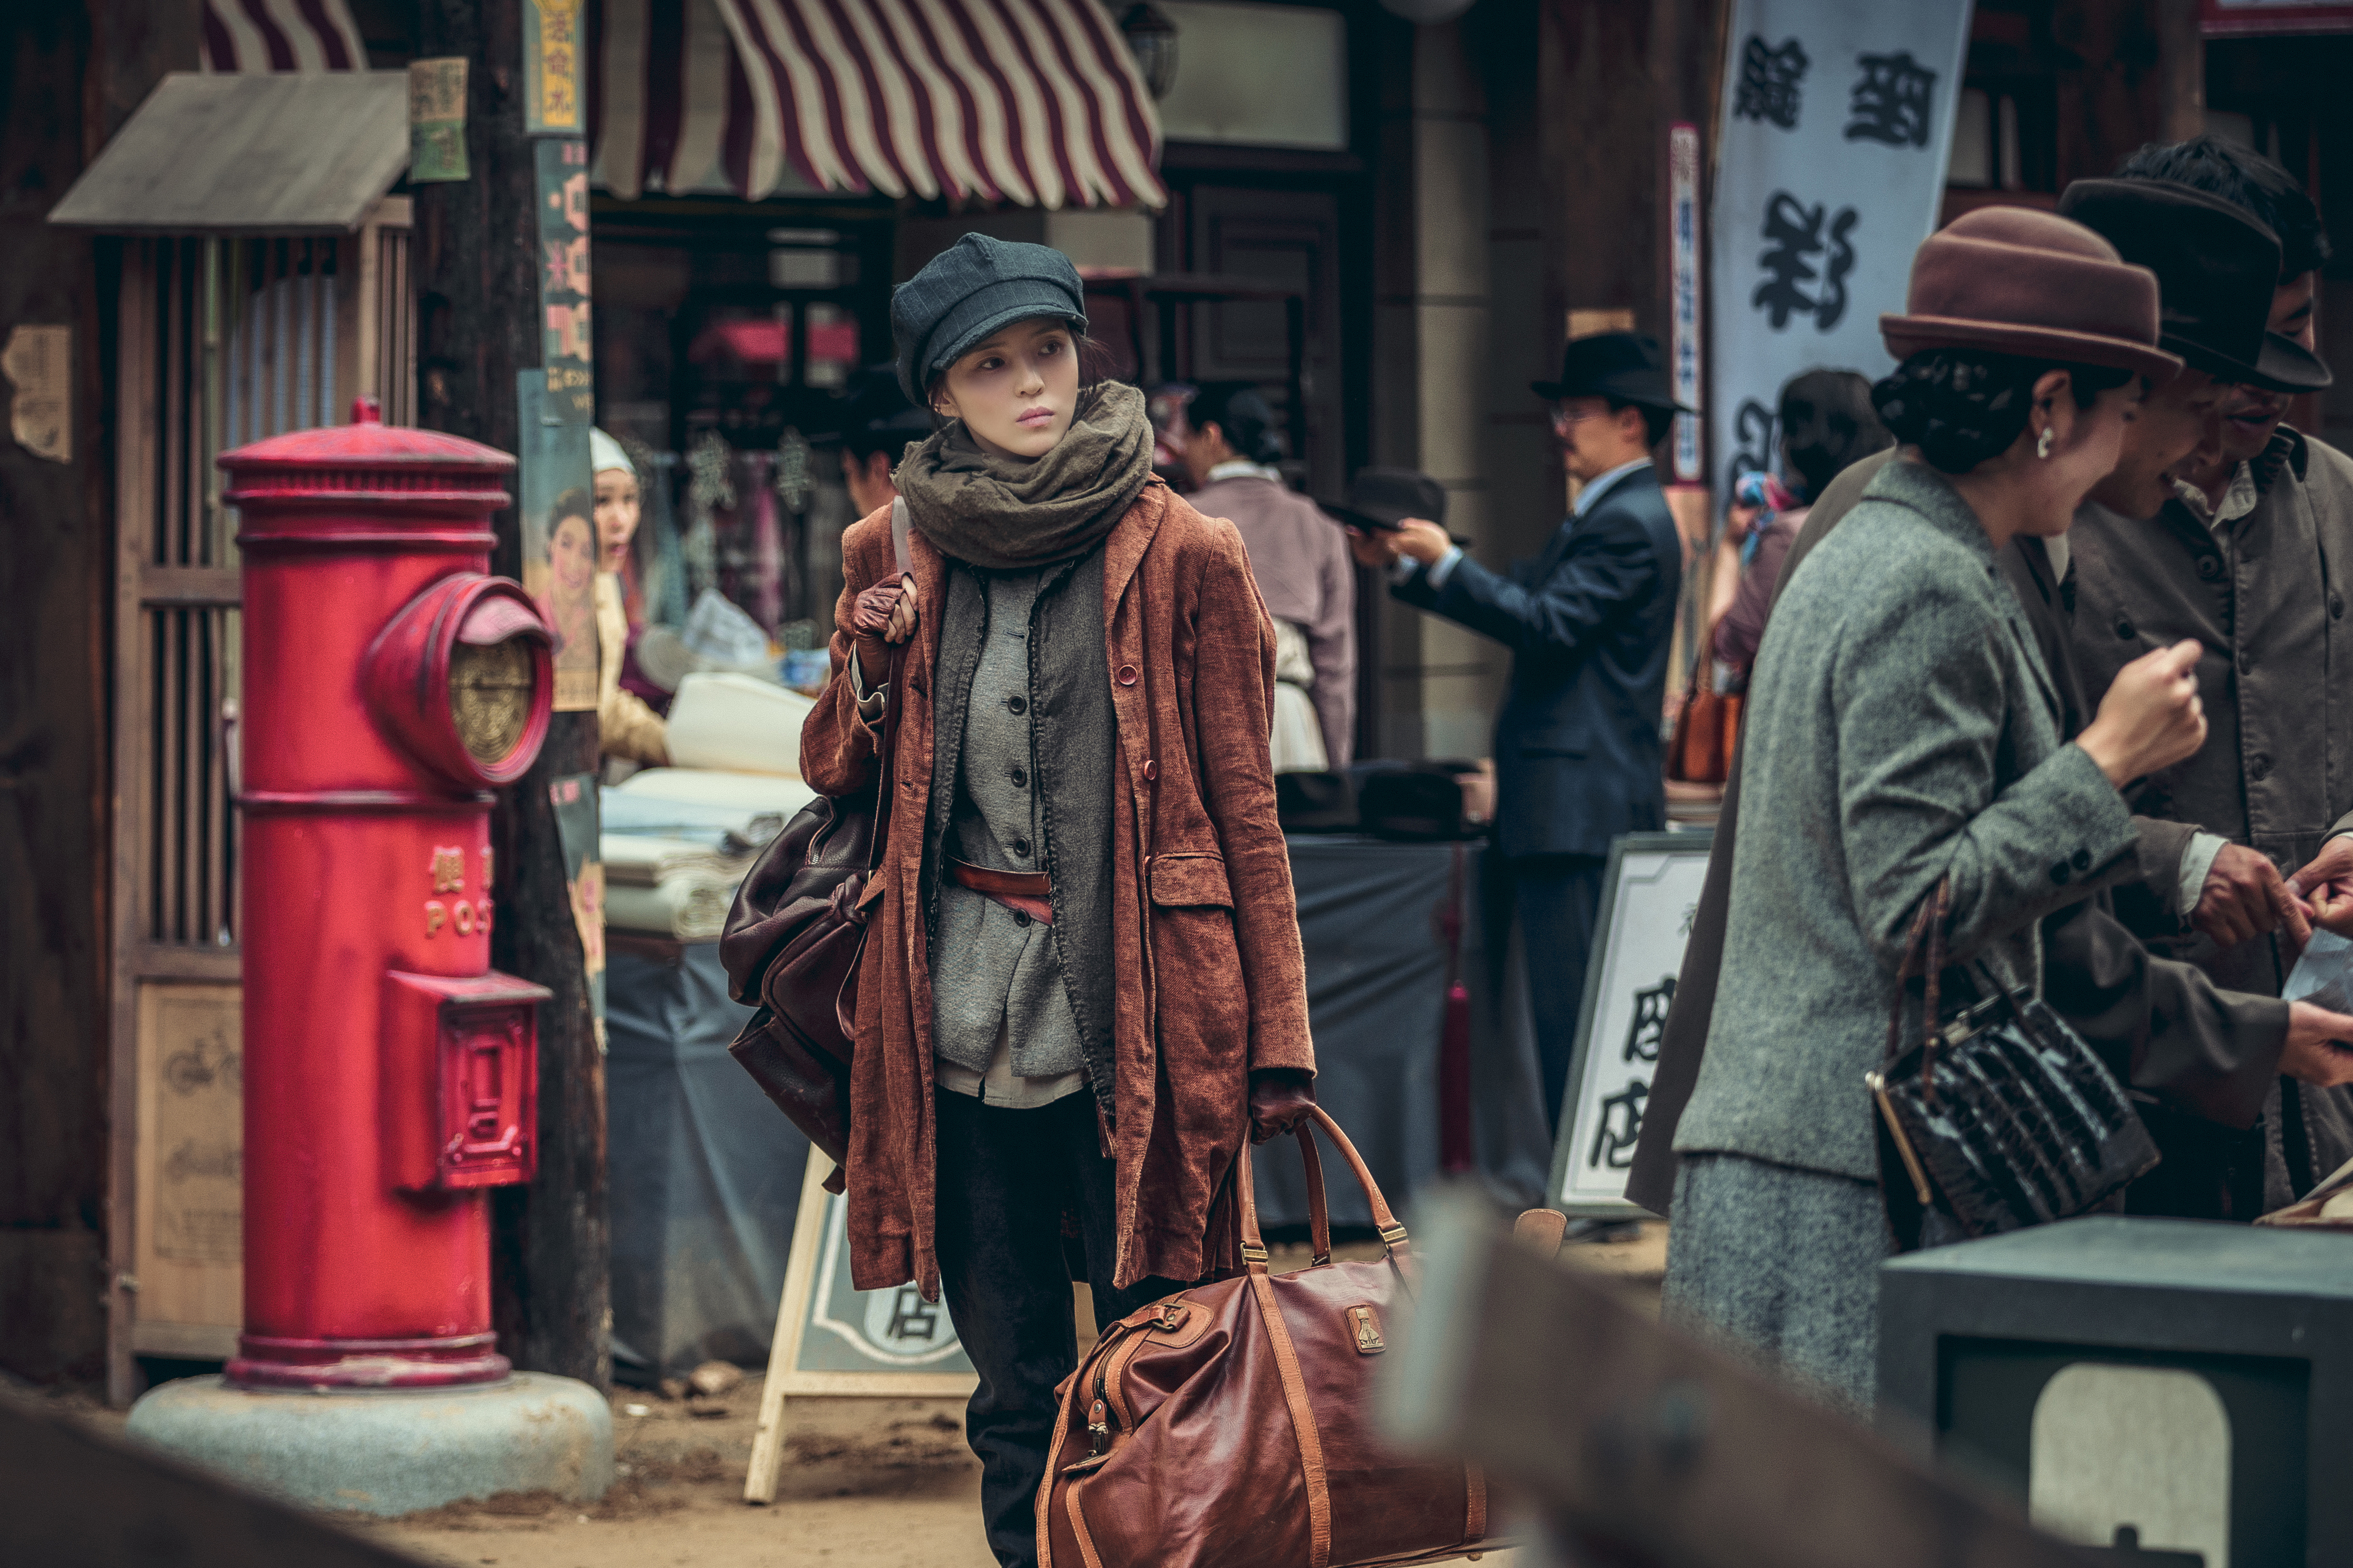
xmin=0 ymin=1394 xmax=419 ymax=1568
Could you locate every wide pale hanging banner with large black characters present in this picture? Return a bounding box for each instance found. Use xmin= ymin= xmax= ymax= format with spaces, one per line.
xmin=1706 ymin=0 xmax=1969 ymax=492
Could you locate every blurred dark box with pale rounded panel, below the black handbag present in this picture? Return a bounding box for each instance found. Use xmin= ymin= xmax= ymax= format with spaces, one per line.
xmin=1880 ymin=1215 xmax=2353 ymax=1568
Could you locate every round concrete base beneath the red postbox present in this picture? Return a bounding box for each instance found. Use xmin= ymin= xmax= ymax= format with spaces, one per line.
xmin=129 ymin=1373 xmax=612 ymax=1516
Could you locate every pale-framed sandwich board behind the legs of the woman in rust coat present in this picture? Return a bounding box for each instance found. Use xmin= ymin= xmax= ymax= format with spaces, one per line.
xmin=744 ymin=1149 xmax=979 ymax=1502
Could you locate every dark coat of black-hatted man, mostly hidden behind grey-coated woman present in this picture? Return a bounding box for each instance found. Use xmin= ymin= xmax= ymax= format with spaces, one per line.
xmin=1626 ymin=455 xmax=2287 ymax=1215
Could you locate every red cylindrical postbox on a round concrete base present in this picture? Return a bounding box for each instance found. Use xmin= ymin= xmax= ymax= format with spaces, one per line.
xmin=221 ymin=401 xmax=555 ymax=1389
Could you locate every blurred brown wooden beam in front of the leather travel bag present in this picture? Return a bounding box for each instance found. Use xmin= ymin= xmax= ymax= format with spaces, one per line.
xmin=1379 ymin=1192 xmax=2104 ymax=1568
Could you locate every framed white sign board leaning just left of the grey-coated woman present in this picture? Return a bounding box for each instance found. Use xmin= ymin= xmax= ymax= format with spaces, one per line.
xmin=1551 ymin=831 xmax=1715 ymax=1220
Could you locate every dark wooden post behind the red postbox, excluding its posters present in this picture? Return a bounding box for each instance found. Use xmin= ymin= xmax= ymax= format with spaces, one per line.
xmin=414 ymin=0 xmax=612 ymax=1389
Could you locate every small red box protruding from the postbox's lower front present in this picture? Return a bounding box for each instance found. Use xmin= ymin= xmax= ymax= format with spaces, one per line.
xmin=381 ymin=970 xmax=548 ymax=1192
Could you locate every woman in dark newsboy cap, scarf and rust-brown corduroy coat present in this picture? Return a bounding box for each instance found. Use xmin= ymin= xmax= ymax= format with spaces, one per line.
xmin=800 ymin=233 xmax=1315 ymax=1563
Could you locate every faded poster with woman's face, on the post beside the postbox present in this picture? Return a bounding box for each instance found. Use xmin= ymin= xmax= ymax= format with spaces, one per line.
xmin=515 ymin=369 xmax=598 ymax=713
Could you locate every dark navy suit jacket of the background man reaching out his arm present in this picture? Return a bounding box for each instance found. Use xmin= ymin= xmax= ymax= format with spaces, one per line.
xmin=1391 ymin=469 xmax=1682 ymax=857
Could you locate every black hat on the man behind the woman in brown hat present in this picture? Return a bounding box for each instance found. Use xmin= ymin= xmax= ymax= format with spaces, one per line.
xmin=2059 ymin=179 xmax=2332 ymax=393
